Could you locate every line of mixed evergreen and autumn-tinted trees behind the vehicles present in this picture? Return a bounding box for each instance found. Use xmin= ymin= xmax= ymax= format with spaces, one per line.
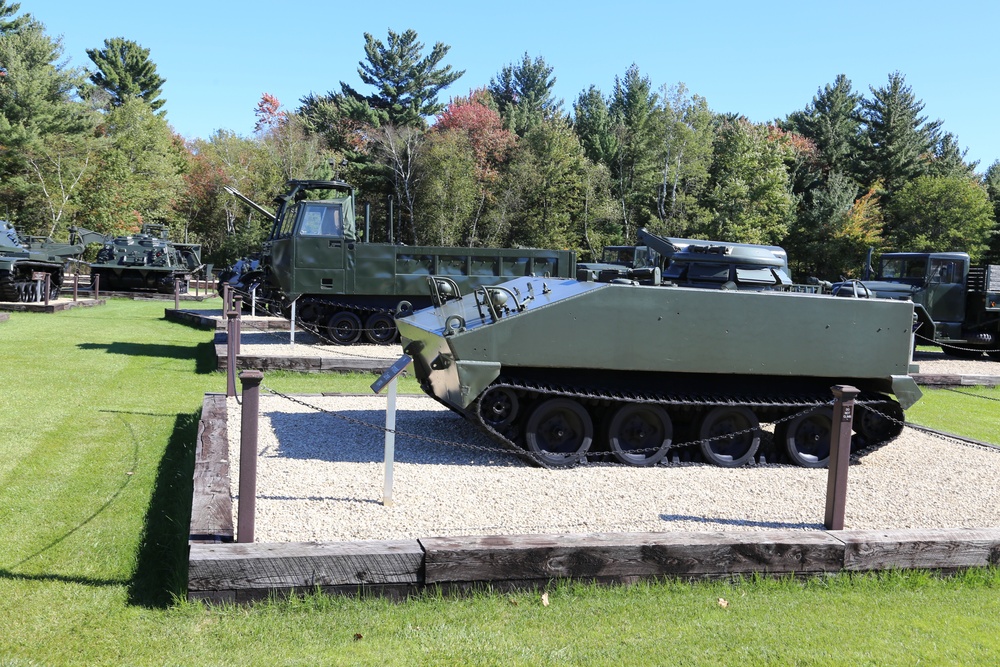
xmin=0 ymin=0 xmax=1000 ymax=279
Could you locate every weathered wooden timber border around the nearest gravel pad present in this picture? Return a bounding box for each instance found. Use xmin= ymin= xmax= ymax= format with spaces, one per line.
xmin=188 ymin=394 xmax=1000 ymax=603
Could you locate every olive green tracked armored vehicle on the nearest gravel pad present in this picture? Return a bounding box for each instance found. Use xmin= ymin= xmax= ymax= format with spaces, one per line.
xmin=397 ymin=278 xmax=920 ymax=467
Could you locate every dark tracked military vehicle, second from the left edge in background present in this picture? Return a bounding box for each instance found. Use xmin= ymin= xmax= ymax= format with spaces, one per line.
xmin=70 ymin=224 xmax=203 ymax=293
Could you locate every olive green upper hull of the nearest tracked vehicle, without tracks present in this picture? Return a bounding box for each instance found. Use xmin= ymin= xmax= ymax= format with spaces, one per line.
xmin=397 ymin=279 xmax=920 ymax=410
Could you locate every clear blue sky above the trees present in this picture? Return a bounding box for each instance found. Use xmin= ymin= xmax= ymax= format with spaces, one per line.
xmin=21 ymin=0 xmax=1000 ymax=172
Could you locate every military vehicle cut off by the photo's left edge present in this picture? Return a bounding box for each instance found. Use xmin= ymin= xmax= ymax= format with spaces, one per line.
xmin=0 ymin=220 xmax=83 ymax=302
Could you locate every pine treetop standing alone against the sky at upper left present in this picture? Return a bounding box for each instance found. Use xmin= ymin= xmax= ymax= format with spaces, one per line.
xmin=87 ymin=37 xmax=166 ymax=116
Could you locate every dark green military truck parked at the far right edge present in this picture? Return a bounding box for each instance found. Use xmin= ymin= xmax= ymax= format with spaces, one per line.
xmin=833 ymin=252 xmax=1000 ymax=359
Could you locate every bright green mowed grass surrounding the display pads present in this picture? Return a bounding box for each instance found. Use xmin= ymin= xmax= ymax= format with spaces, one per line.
xmin=0 ymin=300 xmax=1000 ymax=666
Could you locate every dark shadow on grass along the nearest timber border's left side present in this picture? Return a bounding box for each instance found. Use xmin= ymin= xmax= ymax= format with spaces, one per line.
xmin=128 ymin=410 xmax=201 ymax=607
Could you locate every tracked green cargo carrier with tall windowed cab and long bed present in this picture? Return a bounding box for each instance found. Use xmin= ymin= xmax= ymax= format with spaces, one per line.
xmin=226 ymin=180 xmax=576 ymax=345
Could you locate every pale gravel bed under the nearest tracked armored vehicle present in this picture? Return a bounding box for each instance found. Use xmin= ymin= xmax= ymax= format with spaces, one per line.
xmin=228 ymin=392 xmax=1000 ymax=542
